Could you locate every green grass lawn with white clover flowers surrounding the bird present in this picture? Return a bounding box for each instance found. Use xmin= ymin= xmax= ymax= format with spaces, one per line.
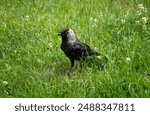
xmin=0 ymin=0 xmax=150 ymax=98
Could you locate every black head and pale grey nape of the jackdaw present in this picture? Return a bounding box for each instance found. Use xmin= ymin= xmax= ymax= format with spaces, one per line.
xmin=58 ymin=28 xmax=75 ymax=40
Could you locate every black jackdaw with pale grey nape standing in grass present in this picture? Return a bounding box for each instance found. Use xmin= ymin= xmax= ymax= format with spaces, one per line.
xmin=58 ymin=29 xmax=100 ymax=68
